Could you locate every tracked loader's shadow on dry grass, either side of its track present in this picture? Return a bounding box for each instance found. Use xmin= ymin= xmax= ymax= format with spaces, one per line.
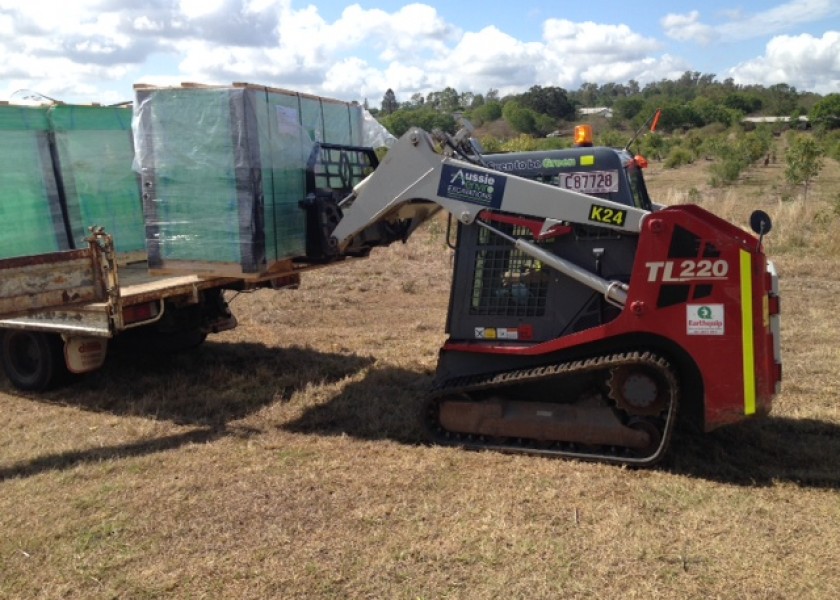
xmin=283 ymin=367 xmax=840 ymax=488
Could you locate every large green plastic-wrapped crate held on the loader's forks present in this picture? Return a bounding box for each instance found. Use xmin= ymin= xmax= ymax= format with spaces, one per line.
xmin=133 ymin=85 xmax=361 ymax=275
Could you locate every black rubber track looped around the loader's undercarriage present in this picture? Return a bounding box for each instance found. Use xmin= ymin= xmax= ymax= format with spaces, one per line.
xmin=425 ymin=351 xmax=679 ymax=466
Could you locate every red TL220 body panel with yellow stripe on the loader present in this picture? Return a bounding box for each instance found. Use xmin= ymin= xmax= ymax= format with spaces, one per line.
xmin=444 ymin=205 xmax=781 ymax=430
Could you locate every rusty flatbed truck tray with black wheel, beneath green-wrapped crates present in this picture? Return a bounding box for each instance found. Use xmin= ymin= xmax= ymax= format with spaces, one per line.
xmin=0 ymin=228 xmax=300 ymax=391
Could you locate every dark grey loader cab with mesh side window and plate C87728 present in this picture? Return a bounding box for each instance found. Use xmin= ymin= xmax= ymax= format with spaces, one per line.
xmin=448 ymin=139 xmax=653 ymax=350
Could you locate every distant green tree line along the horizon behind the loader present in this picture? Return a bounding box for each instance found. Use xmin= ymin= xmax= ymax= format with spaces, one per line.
xmin=372 ymin=71 xmax=840 ymax=137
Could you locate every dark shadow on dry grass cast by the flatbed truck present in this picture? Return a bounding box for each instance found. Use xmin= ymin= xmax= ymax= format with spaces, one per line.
xmin=0 ymin=342 xmax=374 ymax=481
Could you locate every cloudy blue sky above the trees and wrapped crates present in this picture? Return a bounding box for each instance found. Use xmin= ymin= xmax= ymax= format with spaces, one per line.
xmin=0 ymin=0 xmax=840 ymax=106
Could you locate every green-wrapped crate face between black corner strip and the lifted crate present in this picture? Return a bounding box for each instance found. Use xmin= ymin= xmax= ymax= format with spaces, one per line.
xmin=48 ymin=105 xmax=146 ymax=253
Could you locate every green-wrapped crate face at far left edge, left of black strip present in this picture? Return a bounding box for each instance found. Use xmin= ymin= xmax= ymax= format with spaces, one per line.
xmin=0 ymin=105 xmax=72 ymax=258
